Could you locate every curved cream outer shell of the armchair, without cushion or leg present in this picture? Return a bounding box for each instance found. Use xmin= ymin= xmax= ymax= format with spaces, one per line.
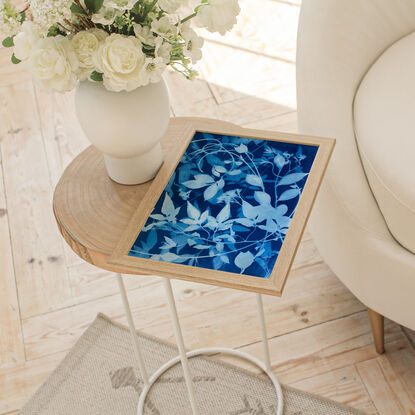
xmin=297 ymin=0 xmax=415 ymax=330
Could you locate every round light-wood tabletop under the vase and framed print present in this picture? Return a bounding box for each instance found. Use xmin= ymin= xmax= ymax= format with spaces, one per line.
xmin=53 ymin=118 xmax=237 ymax=273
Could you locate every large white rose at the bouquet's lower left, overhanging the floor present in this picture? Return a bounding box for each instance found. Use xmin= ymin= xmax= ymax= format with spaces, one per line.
xmin=29 ymin=36 xmax=78 ymax=92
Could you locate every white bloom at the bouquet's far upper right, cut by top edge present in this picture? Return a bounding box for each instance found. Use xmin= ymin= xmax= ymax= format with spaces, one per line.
xmin=196 ymin=0 xmax=241 ymax=35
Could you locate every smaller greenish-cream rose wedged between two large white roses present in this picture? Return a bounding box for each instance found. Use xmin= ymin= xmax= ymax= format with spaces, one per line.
xmin=72 ymin=29 xmax=108 ymax=81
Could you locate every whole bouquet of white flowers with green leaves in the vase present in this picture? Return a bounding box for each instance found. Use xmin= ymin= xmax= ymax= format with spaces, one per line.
xmin=0 ymin=0 xmax=240 ymax=92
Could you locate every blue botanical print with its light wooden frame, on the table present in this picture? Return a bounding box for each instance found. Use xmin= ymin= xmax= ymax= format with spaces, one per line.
xmin=109 ymin=122 xmax=334 ymax=295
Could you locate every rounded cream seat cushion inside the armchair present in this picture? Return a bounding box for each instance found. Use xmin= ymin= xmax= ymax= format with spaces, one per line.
xmin=354 ymin=33 xmax=415 ymax=253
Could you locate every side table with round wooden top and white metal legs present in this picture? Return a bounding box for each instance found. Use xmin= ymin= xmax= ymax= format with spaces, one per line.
xmin=53 ymin=118 xmax=322 ymax=415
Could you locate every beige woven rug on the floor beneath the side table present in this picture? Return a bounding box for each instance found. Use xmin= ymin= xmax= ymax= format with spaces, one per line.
xmin=19 ymin=314 xmax=364 ymax=415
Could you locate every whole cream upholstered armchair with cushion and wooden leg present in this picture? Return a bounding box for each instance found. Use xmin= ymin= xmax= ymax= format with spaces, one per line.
xmin=297 ymin=0 xmax=415 ymax=353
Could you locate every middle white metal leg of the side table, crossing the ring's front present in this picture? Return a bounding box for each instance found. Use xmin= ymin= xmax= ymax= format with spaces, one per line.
xmin=163 ymin=278 xmax=199 ymax=415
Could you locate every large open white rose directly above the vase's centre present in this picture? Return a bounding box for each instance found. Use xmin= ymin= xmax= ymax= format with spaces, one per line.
xmin=94 ymin=33 xmax=145 ymax=92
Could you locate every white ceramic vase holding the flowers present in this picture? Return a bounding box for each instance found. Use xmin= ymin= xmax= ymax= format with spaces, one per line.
xmin=75 ymin=80 xmax=170 ymax=185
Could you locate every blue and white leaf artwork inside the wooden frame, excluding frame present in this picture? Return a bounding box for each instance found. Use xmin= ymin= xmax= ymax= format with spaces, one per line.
xmin=129 ymin=132 xmax=318 ymax=278
